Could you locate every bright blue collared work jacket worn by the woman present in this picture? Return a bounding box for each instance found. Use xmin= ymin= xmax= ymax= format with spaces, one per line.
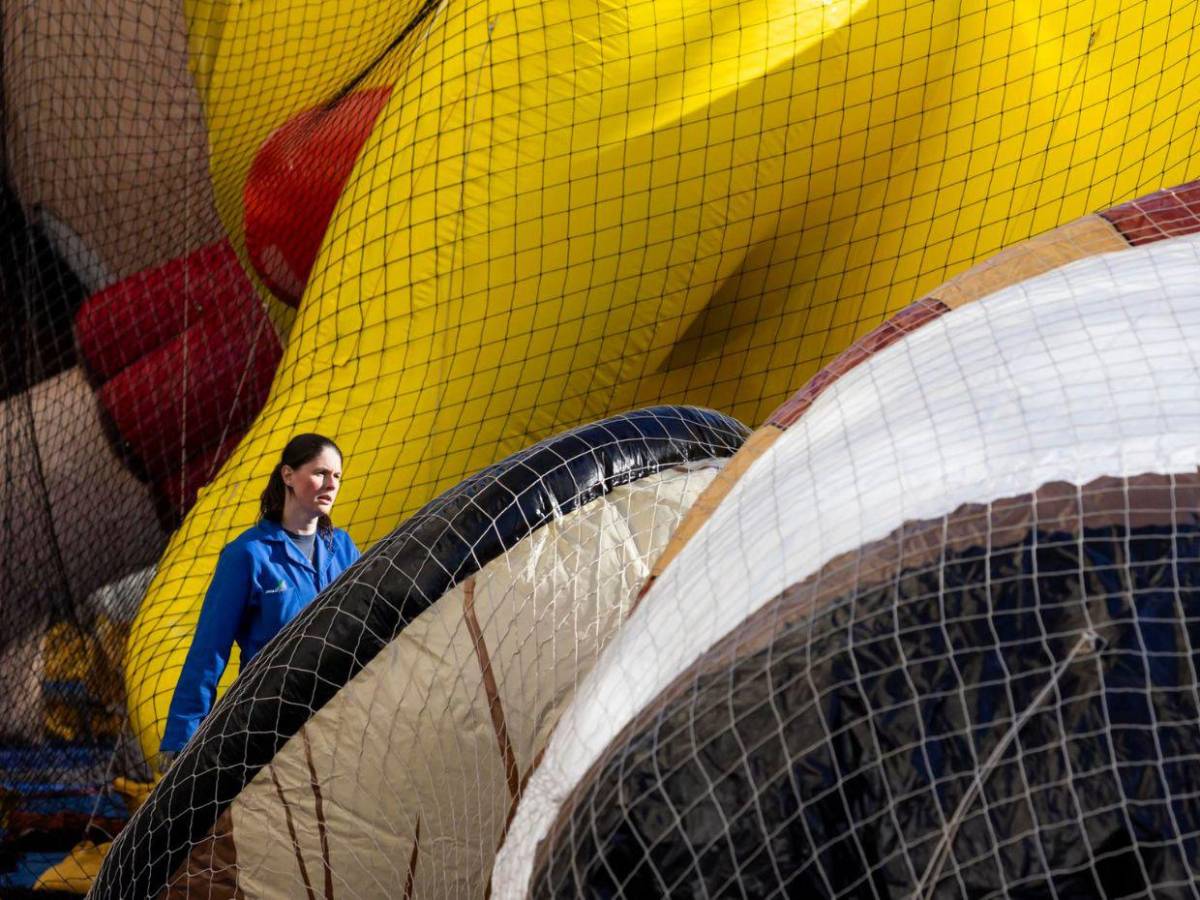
xmin=161 ymin=520 xmax=359 ymax=751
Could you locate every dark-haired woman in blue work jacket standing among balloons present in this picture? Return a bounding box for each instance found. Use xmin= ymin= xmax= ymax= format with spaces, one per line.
xmin=157 ymin=434 xmax=359 ymax=770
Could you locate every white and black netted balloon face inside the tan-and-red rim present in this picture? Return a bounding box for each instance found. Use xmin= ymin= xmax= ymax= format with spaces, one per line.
xmin=493 ymin=230 xmax=1200 ymax=896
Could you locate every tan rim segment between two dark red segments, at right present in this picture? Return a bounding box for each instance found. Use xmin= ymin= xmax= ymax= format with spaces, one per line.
xmin=930 ymin=216 xmax=1129 ymax=310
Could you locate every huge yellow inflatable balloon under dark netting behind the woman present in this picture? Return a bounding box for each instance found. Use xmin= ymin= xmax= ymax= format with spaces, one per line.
xmin=127 ymin=0 xmax=1200 ymax=755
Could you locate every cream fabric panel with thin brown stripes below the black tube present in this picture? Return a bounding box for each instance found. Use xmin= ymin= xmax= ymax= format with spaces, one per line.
xmin=232 ymin=462 xmax=720 ymax=898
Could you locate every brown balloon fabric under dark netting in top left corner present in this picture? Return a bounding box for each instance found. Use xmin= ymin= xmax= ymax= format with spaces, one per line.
xmin=4 ymin=0 xmax=222 ymax=278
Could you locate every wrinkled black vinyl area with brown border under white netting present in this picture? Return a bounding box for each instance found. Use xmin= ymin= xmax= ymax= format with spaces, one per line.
xmin=532 ymin=476 xmax=1200 ymax=898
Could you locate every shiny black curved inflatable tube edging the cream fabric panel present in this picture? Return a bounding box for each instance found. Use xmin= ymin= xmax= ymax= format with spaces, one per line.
xmin=91 ymin=407 xmax=749 ymax=900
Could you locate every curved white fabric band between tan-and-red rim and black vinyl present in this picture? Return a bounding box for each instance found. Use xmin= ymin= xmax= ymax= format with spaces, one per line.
xmin=492 ymin=238 xmax=1200 ymax=898
